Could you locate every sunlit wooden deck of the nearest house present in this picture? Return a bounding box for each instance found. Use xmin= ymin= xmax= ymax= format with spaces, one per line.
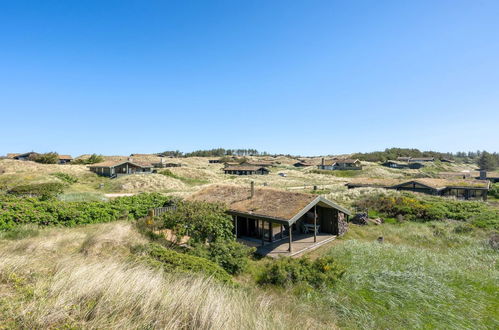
xmin=238 ymin=233 xmax=336 ymax=258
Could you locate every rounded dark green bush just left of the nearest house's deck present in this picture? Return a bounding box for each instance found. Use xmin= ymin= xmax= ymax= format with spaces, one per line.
xmin=190 ymin=240 xmax=255 ymax=275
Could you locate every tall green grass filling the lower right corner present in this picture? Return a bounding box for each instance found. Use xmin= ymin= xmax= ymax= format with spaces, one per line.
xmin=317 ymin=223 xmax=499 ymax=329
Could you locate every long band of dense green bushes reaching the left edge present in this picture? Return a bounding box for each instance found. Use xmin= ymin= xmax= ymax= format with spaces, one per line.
xmin=0 ymin=193 xmax=170 ymax=230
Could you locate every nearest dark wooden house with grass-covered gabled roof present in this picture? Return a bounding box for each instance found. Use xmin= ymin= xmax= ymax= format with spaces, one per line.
xmin=190 ymin=184 xmax=352 ymax=252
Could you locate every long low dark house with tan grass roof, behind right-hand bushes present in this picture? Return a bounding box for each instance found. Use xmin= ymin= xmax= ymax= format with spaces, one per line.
xmin=346 ymin=178 xmax=490 ymax=200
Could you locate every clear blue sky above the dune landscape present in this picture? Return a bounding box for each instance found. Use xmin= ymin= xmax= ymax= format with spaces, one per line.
xmin=0 ymin=0 xmax=499 ymax=155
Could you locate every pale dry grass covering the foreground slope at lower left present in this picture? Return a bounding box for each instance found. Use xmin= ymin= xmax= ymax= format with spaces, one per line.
xmin=0 ymin=222 xmax=332 ymax=329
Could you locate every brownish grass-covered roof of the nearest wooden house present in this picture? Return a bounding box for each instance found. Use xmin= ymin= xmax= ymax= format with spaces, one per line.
xmin=188 ymin=185 xmax=350 ymax=221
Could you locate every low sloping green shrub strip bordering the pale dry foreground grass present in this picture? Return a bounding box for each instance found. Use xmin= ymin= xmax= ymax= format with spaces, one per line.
xmin=134 ymin=244 xmax=232 ymax=282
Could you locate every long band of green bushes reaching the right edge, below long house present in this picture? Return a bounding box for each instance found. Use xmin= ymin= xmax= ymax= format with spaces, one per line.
xmin=355 ymin=194 xmax=499 ymax=228
